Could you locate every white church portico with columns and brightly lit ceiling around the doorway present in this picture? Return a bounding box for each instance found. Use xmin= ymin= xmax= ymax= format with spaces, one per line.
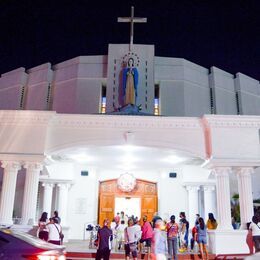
xmin=0 ymin=111 xmax=259 ymax=253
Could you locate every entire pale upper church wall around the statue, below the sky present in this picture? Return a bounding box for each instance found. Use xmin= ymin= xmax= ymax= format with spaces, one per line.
xmin=0 ymin=49 xmax=260 ymax=116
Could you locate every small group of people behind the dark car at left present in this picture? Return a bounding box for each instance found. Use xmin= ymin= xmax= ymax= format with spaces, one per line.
xmin=37 ymin=211 xmax=63 ymax=245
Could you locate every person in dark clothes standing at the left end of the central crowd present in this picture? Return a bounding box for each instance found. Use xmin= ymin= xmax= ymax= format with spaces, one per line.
xmin=96 ymin=219 xmax=113 ymax=260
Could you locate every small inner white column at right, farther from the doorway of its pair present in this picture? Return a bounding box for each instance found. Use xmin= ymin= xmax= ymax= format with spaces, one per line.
xmin=203 ymin=185 xmax=217 ymax=221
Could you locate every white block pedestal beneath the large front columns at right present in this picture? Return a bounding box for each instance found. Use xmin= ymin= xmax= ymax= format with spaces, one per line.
xmin=208 ymin=230 xmax=252 ymax=255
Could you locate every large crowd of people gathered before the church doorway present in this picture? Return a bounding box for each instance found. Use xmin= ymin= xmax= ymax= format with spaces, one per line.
xmin=96 ymin=212 xmax=217 ymax=260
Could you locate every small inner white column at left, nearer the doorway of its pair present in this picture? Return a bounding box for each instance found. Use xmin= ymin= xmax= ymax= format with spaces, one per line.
xmin=57 ymin=183 xmax=70 ymax=226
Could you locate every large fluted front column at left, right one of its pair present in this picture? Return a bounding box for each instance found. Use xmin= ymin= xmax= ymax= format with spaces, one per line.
xmin=22 ymin=162 xmax=42 ymax=225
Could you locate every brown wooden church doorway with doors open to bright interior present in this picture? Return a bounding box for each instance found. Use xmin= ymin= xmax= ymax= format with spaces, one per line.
xmin=98 ymin=179 xmax=158 ymax=225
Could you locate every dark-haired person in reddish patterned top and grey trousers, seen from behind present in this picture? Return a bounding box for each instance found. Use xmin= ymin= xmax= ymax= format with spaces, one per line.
xmin=166 ymin=215 xmax=179 ymax=260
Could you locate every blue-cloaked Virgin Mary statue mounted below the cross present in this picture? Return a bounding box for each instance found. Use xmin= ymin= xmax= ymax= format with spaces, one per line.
xmin=123 ymin=58 xmax=138 ymax=105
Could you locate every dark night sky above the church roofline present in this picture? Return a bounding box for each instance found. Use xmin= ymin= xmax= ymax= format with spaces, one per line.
xmin=0 ymin=0 xmax=260 ymax=80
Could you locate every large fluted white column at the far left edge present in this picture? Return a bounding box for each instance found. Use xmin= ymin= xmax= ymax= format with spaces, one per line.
xmin=0 ymin=161 xmax=21 ymax=225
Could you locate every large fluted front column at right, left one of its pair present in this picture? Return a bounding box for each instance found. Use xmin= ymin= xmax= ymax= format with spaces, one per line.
xmin=213 ymin=167 xmax=232 ymax=230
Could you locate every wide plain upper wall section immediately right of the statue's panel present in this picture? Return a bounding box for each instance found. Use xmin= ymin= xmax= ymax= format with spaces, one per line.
xmin=155 ymin=57 xmax=210 ymax=116
